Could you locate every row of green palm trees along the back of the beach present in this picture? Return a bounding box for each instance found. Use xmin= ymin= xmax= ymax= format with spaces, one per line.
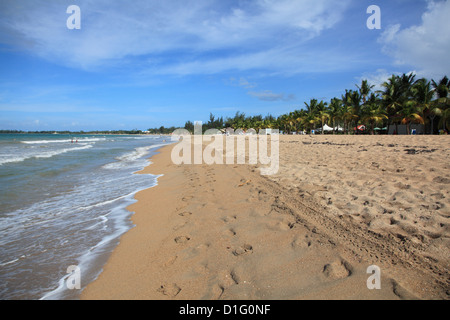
xmin=184 ymin=73 xmax=450 ymax=134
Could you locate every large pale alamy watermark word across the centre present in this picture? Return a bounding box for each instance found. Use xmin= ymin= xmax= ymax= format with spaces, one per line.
xmin=171 ymin=121 xmax=280 ymax=175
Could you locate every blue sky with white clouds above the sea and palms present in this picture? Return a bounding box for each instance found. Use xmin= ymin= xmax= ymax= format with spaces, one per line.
xmin=0 ymin=0 xmax=450 ymax=131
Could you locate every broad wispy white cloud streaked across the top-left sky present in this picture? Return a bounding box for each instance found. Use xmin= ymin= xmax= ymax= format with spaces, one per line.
xmin=0 ymin=0 xmax=349 ymax=74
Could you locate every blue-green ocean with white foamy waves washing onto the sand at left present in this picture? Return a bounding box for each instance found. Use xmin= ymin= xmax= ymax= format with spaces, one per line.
xmin=0 ymin=134 xmax=170 ymax=300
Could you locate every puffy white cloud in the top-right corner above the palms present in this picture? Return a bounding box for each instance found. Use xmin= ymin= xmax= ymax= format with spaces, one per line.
xmin=379 ymin=1 xmax=450 ymax=77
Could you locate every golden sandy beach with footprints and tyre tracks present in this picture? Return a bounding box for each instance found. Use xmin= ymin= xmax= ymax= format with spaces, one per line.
xmin=81 ymin=135 xmax=450 ymax=300
